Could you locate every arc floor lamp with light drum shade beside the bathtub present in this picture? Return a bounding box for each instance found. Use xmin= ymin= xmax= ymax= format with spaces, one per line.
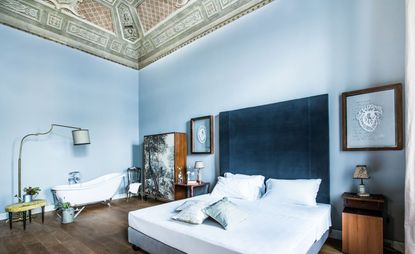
xmin=17 ymin=124 xmax=90 ymax=202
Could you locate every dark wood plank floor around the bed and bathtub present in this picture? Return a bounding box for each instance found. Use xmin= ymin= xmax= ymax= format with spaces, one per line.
xmin=0 ymin=199 xmax=386 ymax=254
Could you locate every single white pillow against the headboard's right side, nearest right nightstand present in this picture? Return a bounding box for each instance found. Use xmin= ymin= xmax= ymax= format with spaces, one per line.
xmin=264 ymin=179 xmax=321 ymax=206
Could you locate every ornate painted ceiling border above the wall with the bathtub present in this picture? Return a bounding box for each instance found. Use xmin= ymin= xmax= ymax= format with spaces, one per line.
xmin=0 ymin=0 xmax=138 ymax=69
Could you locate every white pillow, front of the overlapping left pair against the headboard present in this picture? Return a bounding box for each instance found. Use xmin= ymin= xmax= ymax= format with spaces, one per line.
xmin=211 ymin=176 xmax=261 ymax=201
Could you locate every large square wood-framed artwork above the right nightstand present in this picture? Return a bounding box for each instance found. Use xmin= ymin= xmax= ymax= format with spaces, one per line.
xmin=342 ymin=84 xmax=403 ymax=151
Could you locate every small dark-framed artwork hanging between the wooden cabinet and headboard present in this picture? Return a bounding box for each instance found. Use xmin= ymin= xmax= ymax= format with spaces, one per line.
xmin=190 ymin=116 xmax=213 ymax=154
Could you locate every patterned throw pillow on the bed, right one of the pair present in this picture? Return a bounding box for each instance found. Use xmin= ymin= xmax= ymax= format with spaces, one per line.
xmin=203 ymin=197 xmax=248 ymax=230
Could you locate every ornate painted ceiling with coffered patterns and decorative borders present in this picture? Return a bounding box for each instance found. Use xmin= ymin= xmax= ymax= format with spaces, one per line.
xmin=0 ymin=0 xmax=272 ymax=69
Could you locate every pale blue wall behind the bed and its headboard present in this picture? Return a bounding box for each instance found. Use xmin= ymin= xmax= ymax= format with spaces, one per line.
xmin=139 ymin=0 xmax=405 ymax=241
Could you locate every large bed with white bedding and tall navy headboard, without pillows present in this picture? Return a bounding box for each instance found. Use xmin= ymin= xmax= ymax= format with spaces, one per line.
xmin=128 ymin=95 xmax=331 ymax=254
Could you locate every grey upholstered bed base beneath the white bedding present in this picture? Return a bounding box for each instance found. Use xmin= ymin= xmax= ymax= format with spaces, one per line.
xmin=128 ymin=227 xmax=329 ymax=254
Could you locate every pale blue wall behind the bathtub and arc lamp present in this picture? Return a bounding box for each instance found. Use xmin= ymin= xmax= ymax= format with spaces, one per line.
xmin=0 ymin=25 xmax=138 ymax=213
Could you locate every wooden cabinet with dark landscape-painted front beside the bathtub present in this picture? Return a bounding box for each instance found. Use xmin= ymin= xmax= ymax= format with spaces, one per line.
xmin=143 ymin=132 xmax=187 ymax=201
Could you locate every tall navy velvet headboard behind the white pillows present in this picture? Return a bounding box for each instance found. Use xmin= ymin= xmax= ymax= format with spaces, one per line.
xmin=219 ymin=94 xmax=330 ymax=204
